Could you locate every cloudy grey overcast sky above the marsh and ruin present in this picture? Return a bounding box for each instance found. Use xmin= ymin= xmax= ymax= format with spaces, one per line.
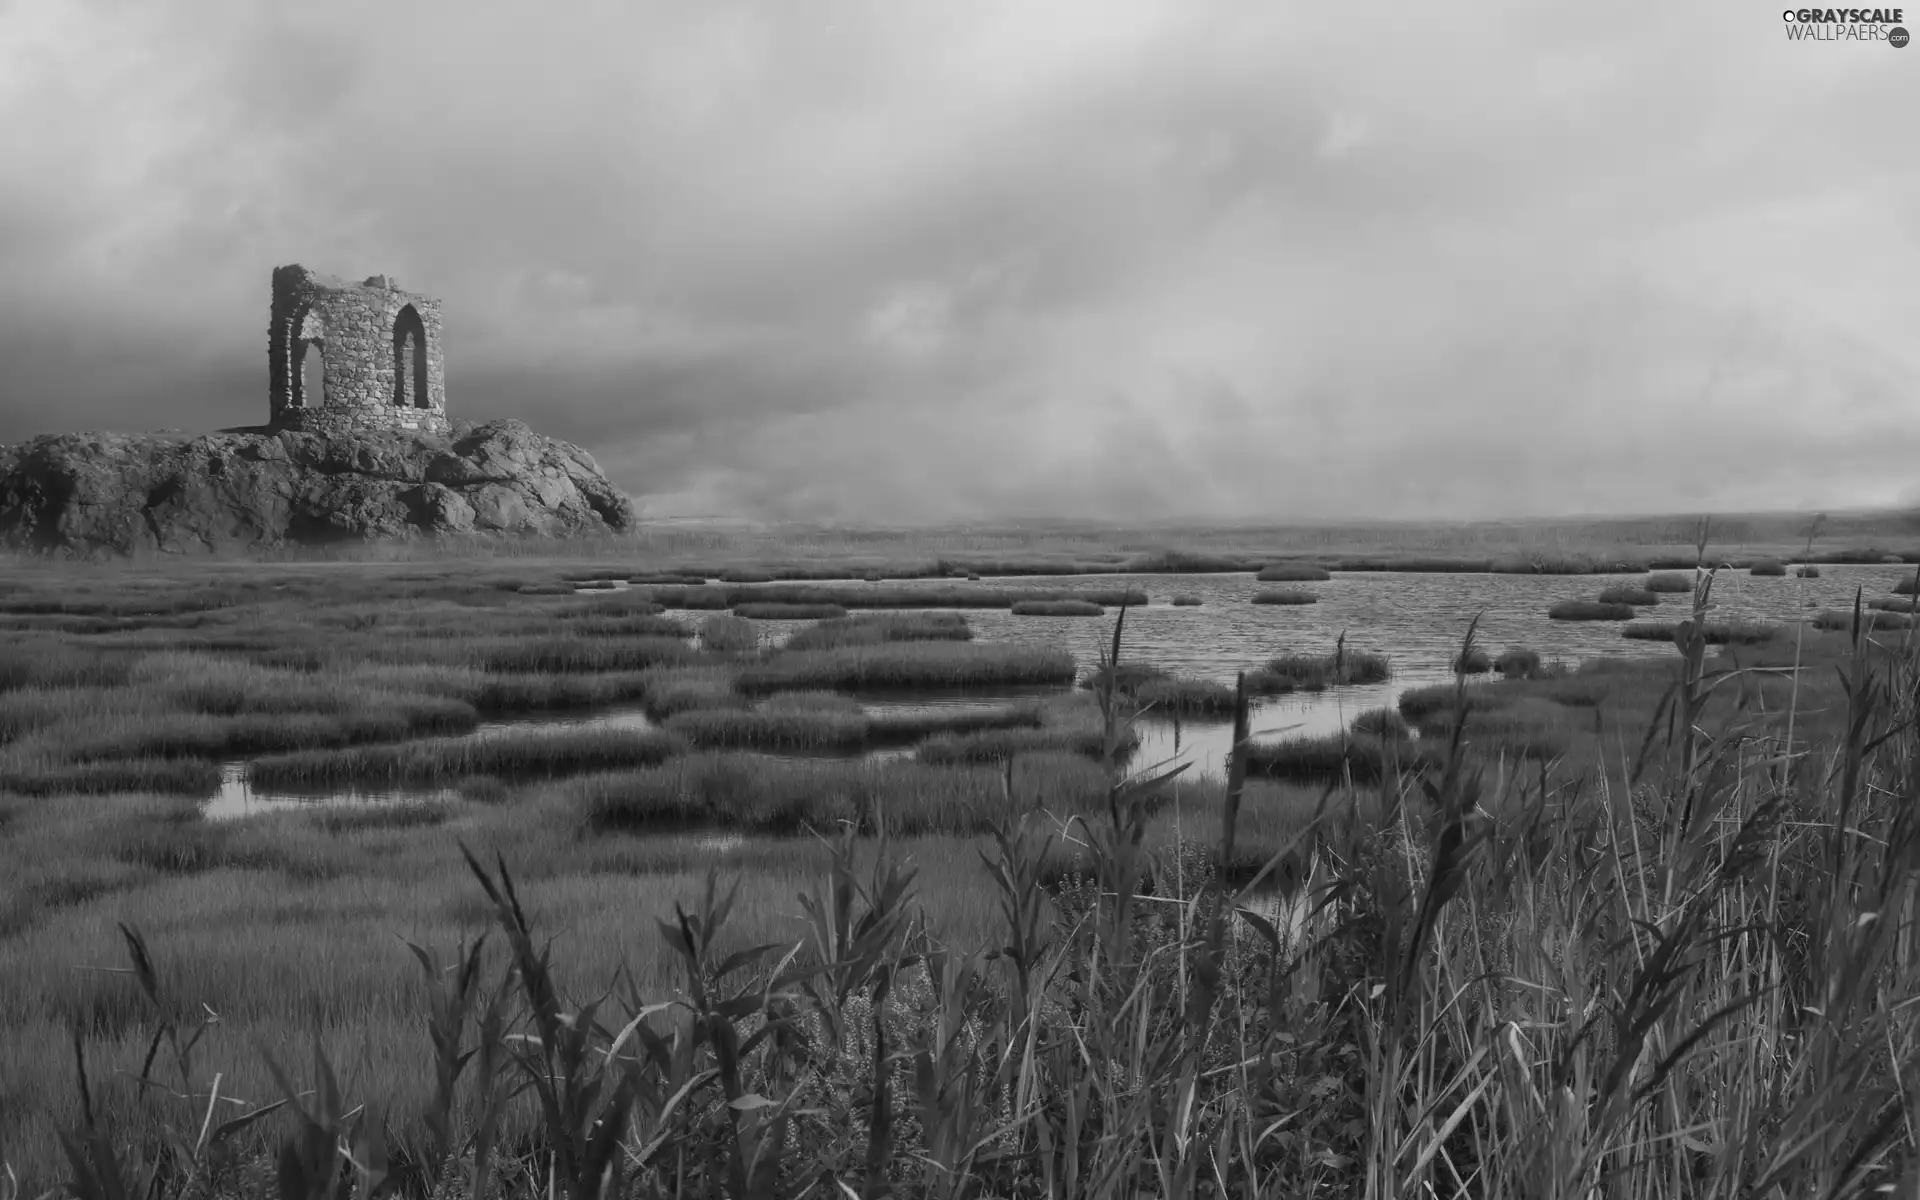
xmin=0 ymin=0 xmax=1920 ymax=520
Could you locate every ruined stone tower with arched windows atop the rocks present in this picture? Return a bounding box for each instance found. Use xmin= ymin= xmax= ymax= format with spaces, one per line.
xmin=267 ymin=265 xmax=449 ymax=434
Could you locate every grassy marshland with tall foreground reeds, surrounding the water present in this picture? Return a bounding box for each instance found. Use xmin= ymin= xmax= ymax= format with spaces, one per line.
xmin=0 ymin=543 xmax=1920 ymax=1198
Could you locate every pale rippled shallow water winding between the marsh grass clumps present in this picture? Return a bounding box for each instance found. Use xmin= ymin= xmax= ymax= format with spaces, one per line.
xmin=204 ymin=564 xmax=1912 ymax=820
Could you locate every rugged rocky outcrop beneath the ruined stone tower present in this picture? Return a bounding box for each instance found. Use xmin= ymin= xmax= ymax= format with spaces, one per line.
xmin=0 ymin=420 xmax=634 ymax=557
